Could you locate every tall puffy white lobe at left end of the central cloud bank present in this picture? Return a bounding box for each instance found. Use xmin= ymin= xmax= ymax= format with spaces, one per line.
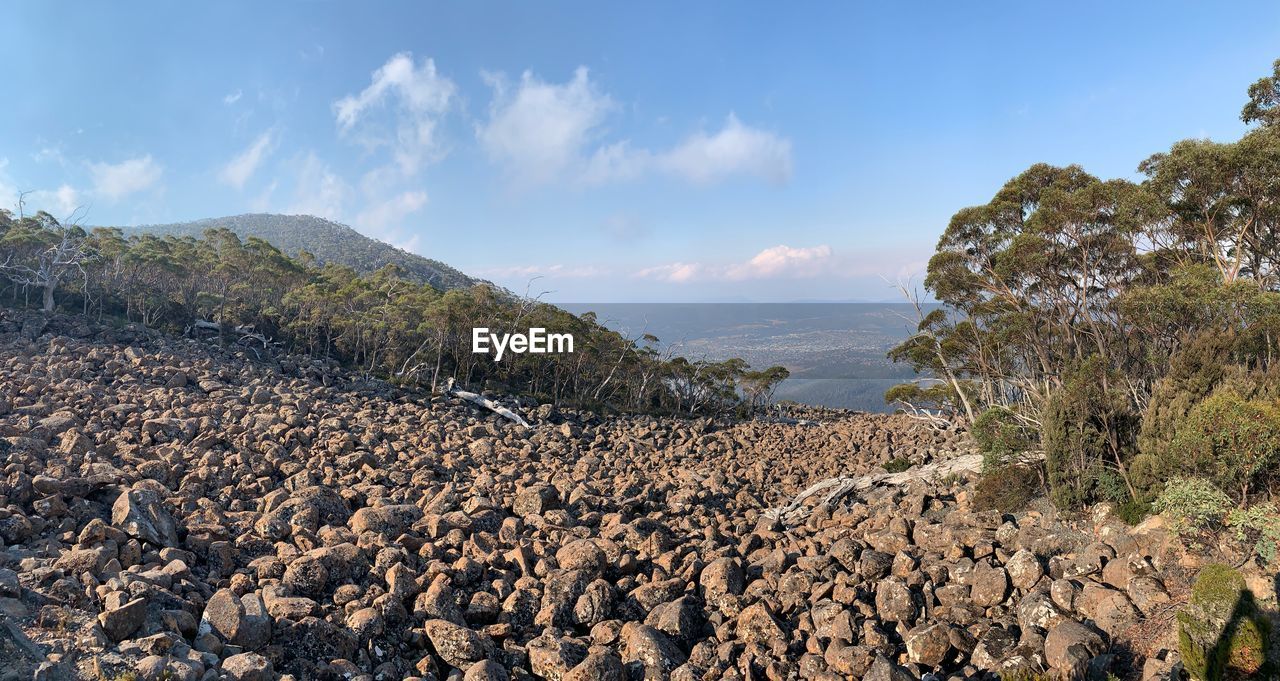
xmin=476 ymin=67 xmax=614 ymax=186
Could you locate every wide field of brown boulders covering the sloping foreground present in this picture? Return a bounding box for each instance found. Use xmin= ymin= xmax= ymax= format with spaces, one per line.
xmin=0 ymin=312 xmax=1178 ymax=681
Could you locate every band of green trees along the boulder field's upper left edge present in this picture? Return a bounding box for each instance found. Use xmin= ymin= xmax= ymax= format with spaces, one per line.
xmin=0 ymin=216 xmax=787 ymax=415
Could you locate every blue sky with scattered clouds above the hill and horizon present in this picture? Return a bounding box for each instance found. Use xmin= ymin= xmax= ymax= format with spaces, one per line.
xmin=0 ymin=1 xmax=1280 ymax=302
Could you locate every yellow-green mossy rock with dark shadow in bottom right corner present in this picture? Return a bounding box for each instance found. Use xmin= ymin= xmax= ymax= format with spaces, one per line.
xmin=1178 ymin=565 xmax=1274 ymax=681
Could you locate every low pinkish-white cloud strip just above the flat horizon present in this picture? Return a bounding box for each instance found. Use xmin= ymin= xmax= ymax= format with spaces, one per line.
xmin=635 ymin=244 xmax=835 ymax=284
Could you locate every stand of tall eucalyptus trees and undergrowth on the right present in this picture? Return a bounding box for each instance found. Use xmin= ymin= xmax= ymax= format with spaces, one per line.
xmin=890 ymin=63 xmax=1280 ymax=535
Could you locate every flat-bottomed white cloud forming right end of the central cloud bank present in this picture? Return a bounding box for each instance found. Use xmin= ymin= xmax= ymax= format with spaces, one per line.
xmin=659 ymin=114 xmax=791 ymax=184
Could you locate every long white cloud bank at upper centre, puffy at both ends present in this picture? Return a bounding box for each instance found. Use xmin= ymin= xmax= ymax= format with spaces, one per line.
xmin=476 ymin=67 xmax=791 ymax=187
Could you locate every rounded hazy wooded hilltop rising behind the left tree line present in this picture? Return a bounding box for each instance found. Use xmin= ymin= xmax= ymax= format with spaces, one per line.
xmin=124 ymin=212 xmax=484 ymax=289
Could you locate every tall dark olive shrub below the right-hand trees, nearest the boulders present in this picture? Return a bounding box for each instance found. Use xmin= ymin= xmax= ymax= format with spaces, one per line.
xmin=1041 ymin=356 xmax=1139 ymax=508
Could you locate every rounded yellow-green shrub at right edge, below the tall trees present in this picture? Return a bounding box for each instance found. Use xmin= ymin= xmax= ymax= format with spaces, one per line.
xmin=1171 ymin=392 xmax=1280 ymax=501
